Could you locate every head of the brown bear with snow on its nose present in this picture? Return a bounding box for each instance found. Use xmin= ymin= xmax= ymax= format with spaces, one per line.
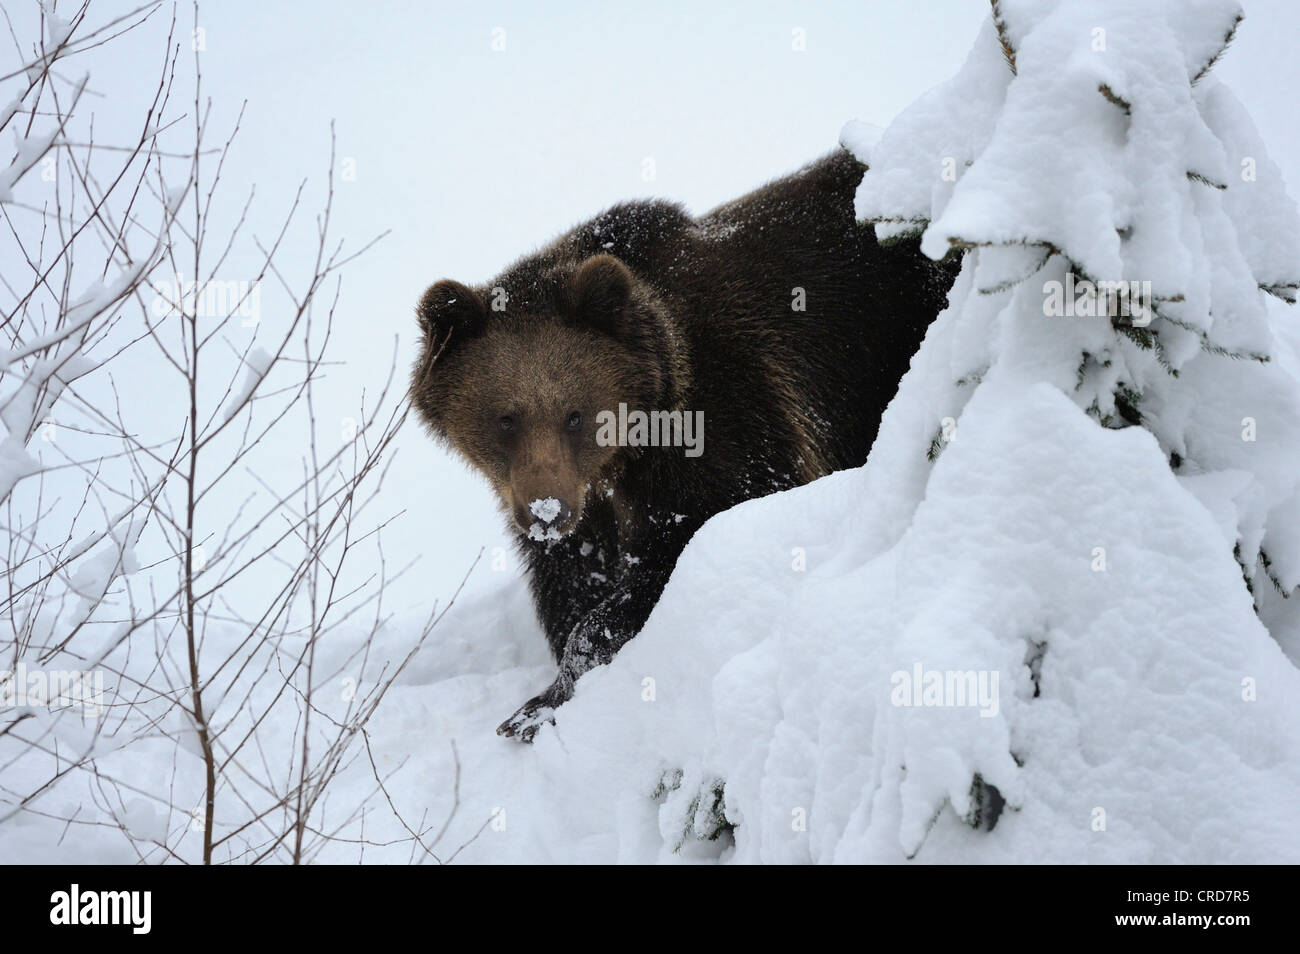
xmin=411 ymin=255 xmax=686 ymax=541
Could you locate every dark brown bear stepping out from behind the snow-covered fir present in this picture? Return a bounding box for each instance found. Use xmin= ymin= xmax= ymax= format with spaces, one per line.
xmin=411 ymin=151 xmax=957 ymax=741
